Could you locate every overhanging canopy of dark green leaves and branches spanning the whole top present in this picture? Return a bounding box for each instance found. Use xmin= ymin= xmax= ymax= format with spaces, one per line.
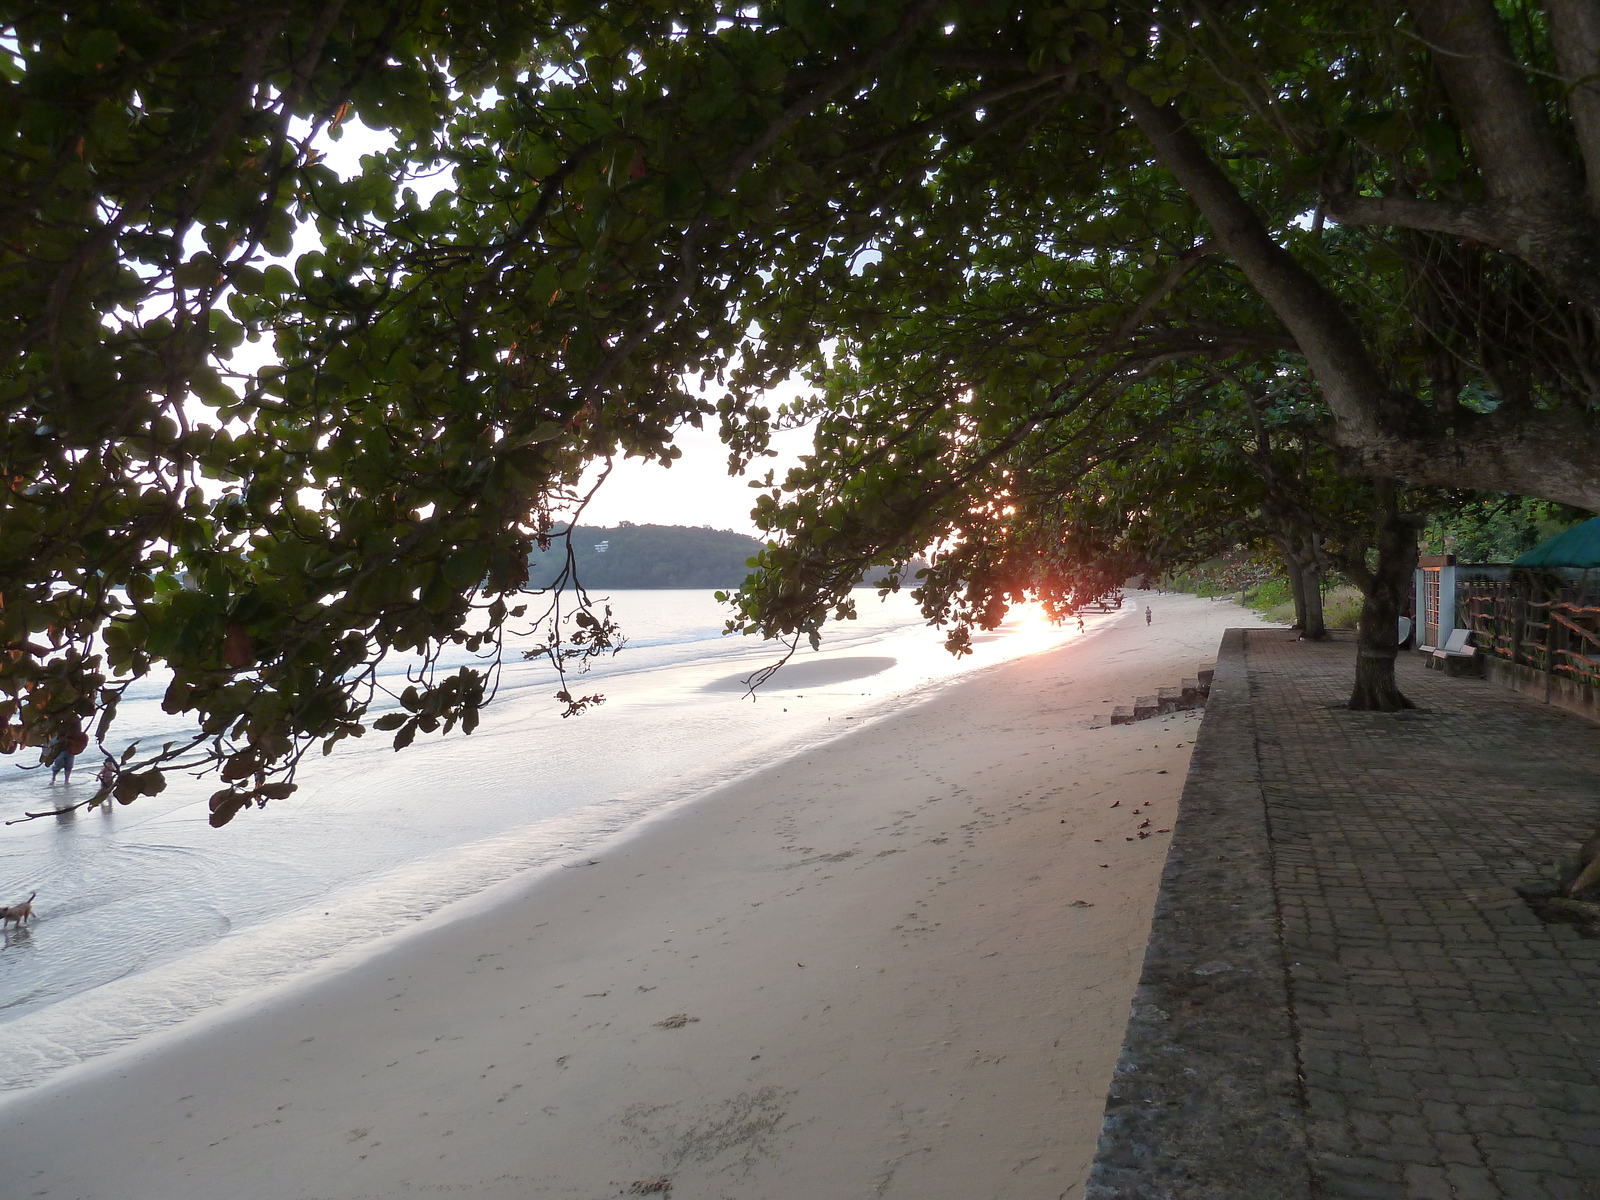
xmin=0 ymin=0 xmax=1600 ymax=821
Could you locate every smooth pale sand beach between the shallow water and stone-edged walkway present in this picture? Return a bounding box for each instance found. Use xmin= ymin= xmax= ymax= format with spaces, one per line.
xmin=0 ymin=594 xmax=1253 ymax=1200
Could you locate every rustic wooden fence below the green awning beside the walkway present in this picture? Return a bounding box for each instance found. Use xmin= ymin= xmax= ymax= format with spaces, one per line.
xmin=1456 ymin=578 xmax=1600 ymax=688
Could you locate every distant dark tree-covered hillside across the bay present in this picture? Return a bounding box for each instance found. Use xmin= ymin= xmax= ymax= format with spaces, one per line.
xmin=530 ymin=522 xmax=762 ymax=590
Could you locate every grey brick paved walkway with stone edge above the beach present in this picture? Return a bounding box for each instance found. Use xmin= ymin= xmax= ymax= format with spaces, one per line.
xmin=1088 ymin=630 xmax=1600 ymax=1200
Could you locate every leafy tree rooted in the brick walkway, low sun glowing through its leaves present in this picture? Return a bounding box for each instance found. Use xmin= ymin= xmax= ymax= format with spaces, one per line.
xmin=713 ymin=70 xmax=1440 ymax=707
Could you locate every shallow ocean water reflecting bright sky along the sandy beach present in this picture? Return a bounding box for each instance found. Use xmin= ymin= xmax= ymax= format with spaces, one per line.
xmin=0 ymin=589 xmax=1094 ymax=1088
